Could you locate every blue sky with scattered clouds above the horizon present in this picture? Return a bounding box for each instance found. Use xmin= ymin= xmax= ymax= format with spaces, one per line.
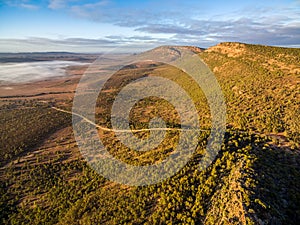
xmin=0 ymin=0 xmax=300 ymax=52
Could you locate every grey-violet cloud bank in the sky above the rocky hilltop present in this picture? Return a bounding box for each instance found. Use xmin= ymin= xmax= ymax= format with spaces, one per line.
xmin=136 ymin=18 xmax=300 ymax=46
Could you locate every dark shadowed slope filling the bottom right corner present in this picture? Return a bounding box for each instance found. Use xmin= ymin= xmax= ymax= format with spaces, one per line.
xmin=249 ymin=144 xmax=300 ymax=225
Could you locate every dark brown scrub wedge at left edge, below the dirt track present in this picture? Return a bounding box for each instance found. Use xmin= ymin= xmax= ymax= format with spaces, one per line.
xmin=0 ymin=101 xmax=70 ymax=165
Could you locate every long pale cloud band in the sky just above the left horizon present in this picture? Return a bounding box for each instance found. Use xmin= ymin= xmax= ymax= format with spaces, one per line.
xmin=0 ymin=36 xmax=169 ymax=53
